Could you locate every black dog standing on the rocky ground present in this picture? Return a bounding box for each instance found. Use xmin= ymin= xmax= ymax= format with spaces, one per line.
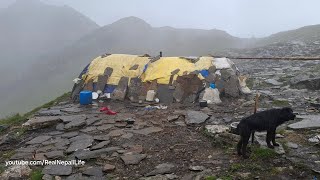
xmin=236 ymin=107 xmax=296 ymax=158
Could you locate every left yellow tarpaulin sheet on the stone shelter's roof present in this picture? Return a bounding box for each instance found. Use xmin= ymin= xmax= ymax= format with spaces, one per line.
xmin=85 ymin=54 xmax=150 ymax=85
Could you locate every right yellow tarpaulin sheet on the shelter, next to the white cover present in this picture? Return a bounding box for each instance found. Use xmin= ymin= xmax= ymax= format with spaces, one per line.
xmin=142 ymin=57 xmax=213 ymax=84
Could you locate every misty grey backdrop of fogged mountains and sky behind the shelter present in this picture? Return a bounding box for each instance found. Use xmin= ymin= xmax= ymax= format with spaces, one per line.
xmin=0 ymin=0 xmax=320 ymax=117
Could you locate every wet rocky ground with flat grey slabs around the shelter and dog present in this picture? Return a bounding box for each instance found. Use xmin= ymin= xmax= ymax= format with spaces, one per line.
xmin=0 ymin=60 xmax=320 ymax=180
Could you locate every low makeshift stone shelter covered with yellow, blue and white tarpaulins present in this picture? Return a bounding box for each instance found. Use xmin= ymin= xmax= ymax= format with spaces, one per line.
xmin=72 ymin=54 xmax=251 ymax=103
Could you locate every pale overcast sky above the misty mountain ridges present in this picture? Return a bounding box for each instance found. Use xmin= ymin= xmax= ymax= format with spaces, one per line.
xmin=5 ymin=0 xmax=320 ymax=37
